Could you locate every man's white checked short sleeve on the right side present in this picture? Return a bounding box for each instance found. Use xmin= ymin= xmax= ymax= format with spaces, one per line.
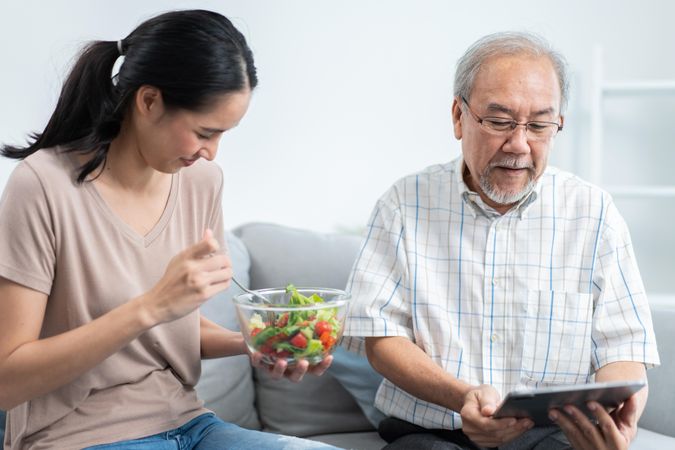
xmin=592 ymin=201 xmax=659 ymax=370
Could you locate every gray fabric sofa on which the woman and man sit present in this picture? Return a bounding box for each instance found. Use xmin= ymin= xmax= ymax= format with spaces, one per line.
xmin=0 ymin=223 xmax=675 ymax=450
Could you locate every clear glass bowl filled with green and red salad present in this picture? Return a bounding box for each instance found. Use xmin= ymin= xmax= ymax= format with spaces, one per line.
xmin=233 ymin=287 xmax=351 ymax=365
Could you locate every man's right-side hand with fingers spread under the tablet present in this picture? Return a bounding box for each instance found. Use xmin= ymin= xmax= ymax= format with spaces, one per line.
xmin=550 ymin=394 xmax=638 ymax=450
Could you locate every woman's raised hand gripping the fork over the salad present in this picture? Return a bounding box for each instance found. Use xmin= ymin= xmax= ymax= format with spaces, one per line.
xmin=140 ymin=230 xmax=232 ymax=324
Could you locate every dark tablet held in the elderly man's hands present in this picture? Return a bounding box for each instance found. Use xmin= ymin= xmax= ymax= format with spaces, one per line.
xmin=493 ymin=380 xmax=647 ymax=426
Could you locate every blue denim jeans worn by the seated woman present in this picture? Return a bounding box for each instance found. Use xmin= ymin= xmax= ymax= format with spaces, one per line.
xmin=84 ymin=413 xmax=336 ymax=450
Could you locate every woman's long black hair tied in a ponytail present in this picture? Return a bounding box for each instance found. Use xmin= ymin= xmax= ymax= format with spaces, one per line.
xmin=0 ymin=10 xmax=258 ymax=183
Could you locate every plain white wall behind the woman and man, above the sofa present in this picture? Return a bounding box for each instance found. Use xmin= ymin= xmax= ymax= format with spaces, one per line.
xmin=0 ymin=0 xmax=675 ymax=289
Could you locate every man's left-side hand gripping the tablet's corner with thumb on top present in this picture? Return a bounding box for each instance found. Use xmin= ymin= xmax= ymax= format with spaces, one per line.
xmin=460 ymin=384 xmax=534 ymax=447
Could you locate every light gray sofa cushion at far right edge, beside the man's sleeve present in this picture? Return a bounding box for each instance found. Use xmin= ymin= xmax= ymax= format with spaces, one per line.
xmin=638 ymin=305 xmax=675 ymax=438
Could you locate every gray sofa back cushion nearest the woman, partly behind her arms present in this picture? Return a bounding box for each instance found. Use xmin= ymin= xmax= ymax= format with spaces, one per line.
xmin=197 ymin=233 xmax=261 ymax=430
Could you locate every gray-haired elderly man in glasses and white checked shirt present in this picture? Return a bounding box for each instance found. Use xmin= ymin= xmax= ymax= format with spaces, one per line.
xmin=345 ymin=33 xmax=659 ymax=449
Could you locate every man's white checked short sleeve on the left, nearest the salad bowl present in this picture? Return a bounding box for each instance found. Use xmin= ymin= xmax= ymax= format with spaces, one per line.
xmin=343 ymin=189 xmax=413 ymax=352
